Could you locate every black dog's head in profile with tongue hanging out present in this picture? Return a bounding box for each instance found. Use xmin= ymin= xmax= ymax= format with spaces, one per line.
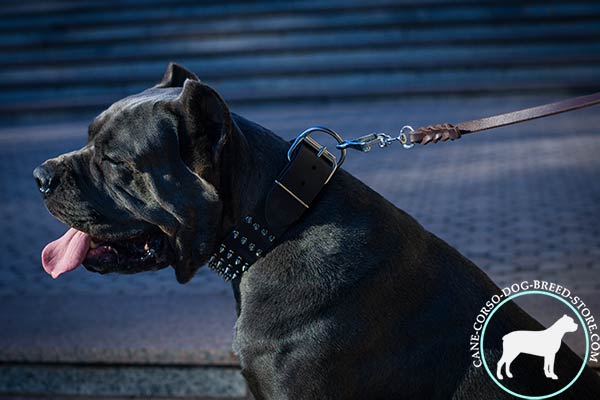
xmin=34 ymin=64 xmax=243 ymax=283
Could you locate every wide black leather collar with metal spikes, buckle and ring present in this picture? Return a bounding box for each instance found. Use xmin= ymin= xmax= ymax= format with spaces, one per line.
xmin=208 ymin=127 xmax=345 ymax=281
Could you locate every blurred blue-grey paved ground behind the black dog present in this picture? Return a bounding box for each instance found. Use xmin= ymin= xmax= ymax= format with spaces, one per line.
xmin=0 ymin=94 xmax=600 ymax=395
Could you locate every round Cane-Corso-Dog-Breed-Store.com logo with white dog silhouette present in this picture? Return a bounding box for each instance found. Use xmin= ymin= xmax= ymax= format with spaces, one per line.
xmin=470 ymin=280 xmax=600 ymax=399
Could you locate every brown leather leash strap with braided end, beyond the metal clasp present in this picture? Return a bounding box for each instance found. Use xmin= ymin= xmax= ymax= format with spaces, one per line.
xmin=408 ymin=92 xmax=600 ymax=144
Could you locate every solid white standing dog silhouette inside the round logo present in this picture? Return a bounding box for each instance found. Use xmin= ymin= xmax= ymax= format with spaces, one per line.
xmin=496 ymin=315 xmax=578 ymax=380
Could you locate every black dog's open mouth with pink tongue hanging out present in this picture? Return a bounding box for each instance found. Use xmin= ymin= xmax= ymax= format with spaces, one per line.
xmin=42 ymin=228 xmax=171 ymax=278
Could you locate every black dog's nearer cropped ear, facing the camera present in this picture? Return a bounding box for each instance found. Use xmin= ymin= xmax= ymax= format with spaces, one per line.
xmin=177 ymin=79 xmax=233 ymax=166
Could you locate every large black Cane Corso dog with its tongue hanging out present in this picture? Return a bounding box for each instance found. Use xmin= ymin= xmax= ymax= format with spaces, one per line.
xmin=34 ymin=64 xmax=600 ymax=400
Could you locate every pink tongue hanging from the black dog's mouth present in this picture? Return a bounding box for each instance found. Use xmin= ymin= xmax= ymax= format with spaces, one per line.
xmin=42 ymin=228 xmax=91 ymax=279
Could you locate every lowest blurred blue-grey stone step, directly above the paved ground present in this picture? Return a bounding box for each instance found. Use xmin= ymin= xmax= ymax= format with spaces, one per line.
xmin=0 ymin=65 xmax=600 ymax=117
